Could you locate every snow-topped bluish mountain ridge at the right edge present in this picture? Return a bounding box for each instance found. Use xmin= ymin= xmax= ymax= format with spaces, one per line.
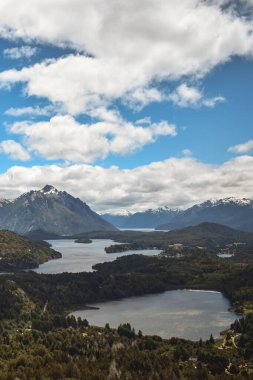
xmin=156 ymin=198 xmax=253 ymax=232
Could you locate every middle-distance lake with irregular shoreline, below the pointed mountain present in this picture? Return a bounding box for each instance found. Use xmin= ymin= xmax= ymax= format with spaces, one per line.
xmin=34 ymin=239 xmax=161 ymax=274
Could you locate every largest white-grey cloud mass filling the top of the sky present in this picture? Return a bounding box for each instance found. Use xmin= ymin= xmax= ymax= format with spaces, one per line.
xmin=0 ymin=0 xmax=253 ymax=114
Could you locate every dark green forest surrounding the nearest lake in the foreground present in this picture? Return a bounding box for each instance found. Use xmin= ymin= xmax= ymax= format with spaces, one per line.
xmin=0 ymin=246 xmax=253 ymax=380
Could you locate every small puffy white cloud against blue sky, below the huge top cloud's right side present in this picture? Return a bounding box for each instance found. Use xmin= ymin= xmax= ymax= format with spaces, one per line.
xmin=168 ymin=83 xmax=225 ymax=107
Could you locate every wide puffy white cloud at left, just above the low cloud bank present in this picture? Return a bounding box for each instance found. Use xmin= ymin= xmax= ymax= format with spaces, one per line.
xmin=9 ymin=113 xmax=176 ymax=162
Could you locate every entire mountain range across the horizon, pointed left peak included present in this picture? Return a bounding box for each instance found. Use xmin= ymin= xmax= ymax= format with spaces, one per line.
xmin=0 ymin=185 xmax=253 ymax=236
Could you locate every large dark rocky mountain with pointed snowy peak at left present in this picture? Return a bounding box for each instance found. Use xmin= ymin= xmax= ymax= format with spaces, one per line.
xmin=0 ymin=185 xmax=115 ymax=235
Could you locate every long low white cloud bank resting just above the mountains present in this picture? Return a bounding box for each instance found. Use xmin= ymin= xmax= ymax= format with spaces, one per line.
xmin=0 ymin=156 xmax=253 ymax=212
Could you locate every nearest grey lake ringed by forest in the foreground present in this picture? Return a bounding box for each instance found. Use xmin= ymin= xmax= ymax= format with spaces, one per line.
xmin=72 ymin=290 xmax=238 ymax=340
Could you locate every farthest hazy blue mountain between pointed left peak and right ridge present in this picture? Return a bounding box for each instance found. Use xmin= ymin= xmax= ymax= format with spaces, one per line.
xmin=102 ymin=207 xmax=181 ymax=228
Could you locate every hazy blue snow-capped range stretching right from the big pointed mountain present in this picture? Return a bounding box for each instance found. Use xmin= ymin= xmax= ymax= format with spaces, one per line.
xmin=103 ymin=197 xmax=253 ymax=232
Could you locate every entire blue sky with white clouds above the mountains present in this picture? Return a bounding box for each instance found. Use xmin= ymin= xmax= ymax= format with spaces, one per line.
xmin=0 ymin=0 xmax=253 ymax=213
